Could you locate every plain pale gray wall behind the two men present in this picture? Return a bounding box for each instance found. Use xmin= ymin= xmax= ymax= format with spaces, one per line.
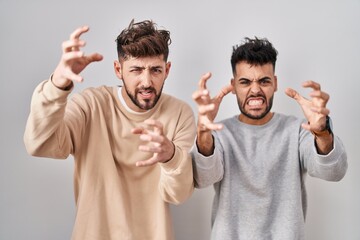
xmin=0 ymin=0 xmax=360 ymax=240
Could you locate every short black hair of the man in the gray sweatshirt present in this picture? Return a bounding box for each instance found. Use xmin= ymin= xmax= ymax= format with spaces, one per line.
xmin=231 ymin=37 xmax=278 ymax=74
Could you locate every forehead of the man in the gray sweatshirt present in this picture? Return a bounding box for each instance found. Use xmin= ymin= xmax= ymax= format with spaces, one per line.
xmin=235 ymin=62 xmax=274 ymax=79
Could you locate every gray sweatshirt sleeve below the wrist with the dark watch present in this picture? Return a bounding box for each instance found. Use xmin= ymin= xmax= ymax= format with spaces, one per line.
xmin=300 ymin=130 xmax=348 ymax=181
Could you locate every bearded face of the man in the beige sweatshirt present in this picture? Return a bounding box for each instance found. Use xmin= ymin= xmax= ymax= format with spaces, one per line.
xmin=114 ymin=55 xmax=171 ymax=112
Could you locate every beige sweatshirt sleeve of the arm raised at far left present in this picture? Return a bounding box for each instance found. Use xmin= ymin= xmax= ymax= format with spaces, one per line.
xmin=24 ymin=80 xmax=85 ymax=159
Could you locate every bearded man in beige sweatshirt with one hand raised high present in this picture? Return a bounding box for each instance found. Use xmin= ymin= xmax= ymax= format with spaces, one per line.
xmin=24 ymin=20 xmax=195 ymax=240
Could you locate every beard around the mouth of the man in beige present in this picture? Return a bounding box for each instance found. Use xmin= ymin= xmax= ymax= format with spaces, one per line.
xmin=124 ymin=82 xmax=164 ymax=110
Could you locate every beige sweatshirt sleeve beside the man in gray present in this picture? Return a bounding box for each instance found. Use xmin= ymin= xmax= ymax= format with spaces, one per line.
xmin=159 ymin=105 xmax=195 ymax=204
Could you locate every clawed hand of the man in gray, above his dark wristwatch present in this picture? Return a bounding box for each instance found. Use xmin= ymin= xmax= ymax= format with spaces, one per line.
xmin=285 ymin=81 xmax=330 ymax=132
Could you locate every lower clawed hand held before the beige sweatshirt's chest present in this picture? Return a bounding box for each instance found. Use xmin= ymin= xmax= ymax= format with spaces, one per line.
xmin=132 ymin=119 xmax=175 ymax=167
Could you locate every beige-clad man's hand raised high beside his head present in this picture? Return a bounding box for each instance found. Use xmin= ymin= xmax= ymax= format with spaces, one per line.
xmin=52 ymin=26 xmax=103 ymax=89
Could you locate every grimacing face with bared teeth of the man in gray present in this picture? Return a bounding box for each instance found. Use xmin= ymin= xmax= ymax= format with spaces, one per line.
xmin=231 ymin=62 xmax=277 ymax=125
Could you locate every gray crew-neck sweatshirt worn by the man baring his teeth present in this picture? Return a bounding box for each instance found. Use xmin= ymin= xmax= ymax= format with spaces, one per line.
xmin=192 ymin=113 xmax=347 ymax=240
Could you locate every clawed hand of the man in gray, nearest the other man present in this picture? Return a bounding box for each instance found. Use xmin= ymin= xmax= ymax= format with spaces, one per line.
xmin=192 ymin=73 xmax=233 ymax=132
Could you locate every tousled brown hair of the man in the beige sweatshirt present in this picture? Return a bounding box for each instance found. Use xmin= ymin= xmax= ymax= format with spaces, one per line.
xmin=116 ymin=19 xmax=171 ymax=61
